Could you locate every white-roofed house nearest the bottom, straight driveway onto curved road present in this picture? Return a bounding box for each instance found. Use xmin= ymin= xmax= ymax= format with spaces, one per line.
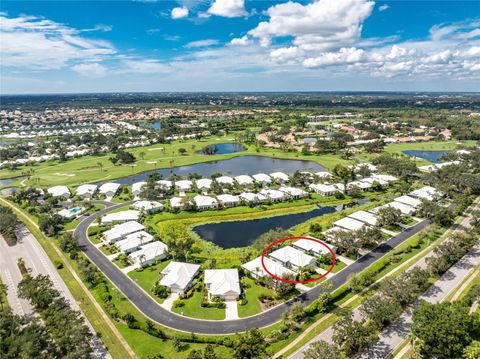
xmin=204 ymin=269 xmax=241 ymax=300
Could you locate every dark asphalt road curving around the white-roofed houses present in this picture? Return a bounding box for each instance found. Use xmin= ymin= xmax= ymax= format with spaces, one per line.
xmin=75 ymin=202 xmax=430 ymax=335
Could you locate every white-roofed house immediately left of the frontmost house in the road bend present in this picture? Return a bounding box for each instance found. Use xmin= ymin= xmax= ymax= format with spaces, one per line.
xmin=160 ymin=261 xmax=200 ymax=293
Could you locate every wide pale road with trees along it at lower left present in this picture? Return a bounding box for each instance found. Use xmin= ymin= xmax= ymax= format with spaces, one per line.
xmin=0 ymin=226 xmax=110 ymax=358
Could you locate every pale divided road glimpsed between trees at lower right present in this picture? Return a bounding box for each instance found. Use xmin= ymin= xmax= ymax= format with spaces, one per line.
xmin=289 ymin=202 xmax=480 ymax=359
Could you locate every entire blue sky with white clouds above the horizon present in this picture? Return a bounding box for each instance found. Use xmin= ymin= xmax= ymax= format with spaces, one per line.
xmin=0 ymin=0 xmax=480 ymax=94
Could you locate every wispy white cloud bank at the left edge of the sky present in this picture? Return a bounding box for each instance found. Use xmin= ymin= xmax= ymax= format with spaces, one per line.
xmin=0 ymin=14 xmax=116 ymax=70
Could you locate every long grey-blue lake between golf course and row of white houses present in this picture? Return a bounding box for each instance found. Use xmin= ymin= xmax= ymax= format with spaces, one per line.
xmin=108 ymin=156 xmax=325 ymax=185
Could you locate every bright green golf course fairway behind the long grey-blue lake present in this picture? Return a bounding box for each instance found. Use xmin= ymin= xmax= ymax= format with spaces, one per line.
xmin=0 ymin=134 xmax=348 ymax=187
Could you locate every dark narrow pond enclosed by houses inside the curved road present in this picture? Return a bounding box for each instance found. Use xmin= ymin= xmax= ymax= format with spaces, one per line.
xmin=193 ymin=206 xmax=343 ymax=248
